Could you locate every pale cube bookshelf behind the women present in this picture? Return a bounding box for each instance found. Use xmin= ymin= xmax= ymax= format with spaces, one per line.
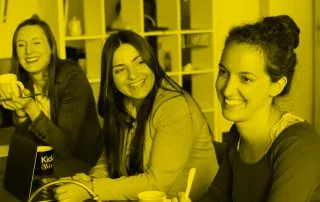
xmin=39 ymin=0 xmax=221 ymax=141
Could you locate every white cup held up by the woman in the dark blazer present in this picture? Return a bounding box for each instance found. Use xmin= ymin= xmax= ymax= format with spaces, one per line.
xmin=0 ymin=73 xmax=24 ymax=96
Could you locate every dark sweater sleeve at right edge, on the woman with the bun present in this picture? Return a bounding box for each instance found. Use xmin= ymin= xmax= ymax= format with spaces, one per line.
xmin=267 ymin=124 xmax=320 ymax=202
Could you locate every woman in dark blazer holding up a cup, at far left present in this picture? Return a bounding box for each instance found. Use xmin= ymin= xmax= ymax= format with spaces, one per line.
xmin=0 ymin=16 xmax=103 ymax=165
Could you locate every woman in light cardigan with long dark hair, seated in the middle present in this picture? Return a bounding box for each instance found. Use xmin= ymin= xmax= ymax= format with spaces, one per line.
xmin=56 ymin=31 xmax=218 ymax=201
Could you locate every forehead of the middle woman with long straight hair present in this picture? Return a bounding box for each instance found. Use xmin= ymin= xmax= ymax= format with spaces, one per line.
xmin=113 ymin=43 xmax=140 ymax=63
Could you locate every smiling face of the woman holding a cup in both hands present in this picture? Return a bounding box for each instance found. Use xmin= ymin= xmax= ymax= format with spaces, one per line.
xmin=16 ymin=25 xmax=52 ymax=74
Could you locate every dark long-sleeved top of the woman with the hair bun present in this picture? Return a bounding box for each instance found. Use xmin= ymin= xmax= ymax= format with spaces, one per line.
xmin=200 ymin=113 xmax=320 ymax=202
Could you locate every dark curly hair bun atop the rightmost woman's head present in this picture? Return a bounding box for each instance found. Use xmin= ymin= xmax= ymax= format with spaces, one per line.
xmin=262 ymin=15 xmax=300 ymax=49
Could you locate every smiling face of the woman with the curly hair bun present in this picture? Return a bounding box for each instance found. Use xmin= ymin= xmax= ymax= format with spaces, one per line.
xmin=216 ymin=43 xmax=276 ymax=122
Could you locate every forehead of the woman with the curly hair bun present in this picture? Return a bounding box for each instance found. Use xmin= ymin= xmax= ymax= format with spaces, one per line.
xmin=220 ymin=43 xmax=265 ymax=73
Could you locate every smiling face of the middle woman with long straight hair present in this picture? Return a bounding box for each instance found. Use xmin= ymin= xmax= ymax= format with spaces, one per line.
xmin=112 ymin=43 xmax=155 ymax=100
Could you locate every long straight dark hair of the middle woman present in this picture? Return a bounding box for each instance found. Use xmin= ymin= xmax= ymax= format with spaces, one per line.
xmin=98 ymin=31 xmax=183 ymax=178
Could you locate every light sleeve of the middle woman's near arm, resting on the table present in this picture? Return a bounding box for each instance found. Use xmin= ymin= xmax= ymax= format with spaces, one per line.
xmin=93 ymin=96 xmax=199 ymax=200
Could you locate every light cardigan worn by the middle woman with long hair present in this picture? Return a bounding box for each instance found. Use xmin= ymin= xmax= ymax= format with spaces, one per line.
xmin=89 ymin=89 xmax=218 ymax=200
